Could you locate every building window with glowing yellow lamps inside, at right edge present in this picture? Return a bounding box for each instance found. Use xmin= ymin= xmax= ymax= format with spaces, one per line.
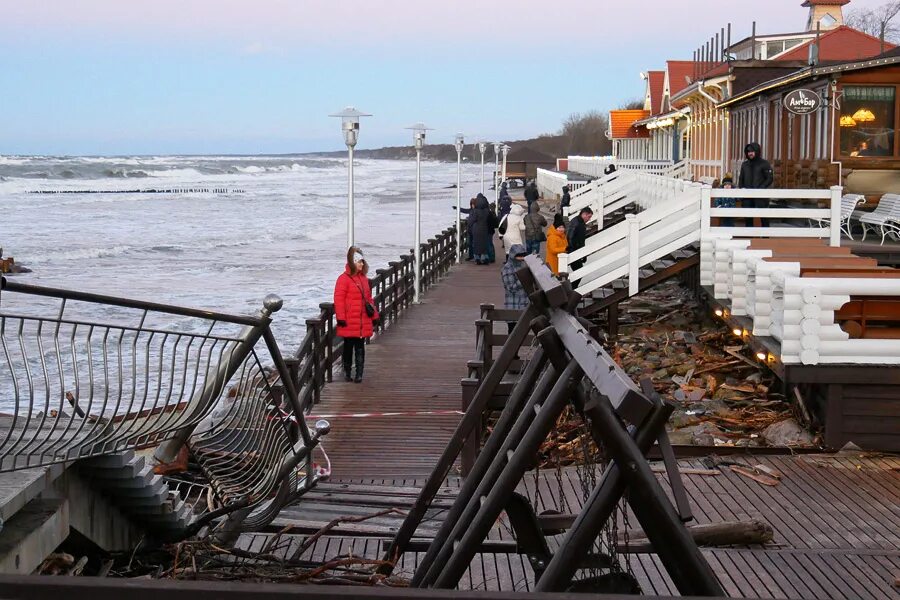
xmin=840 ymin=85 xmax=896 ymax=157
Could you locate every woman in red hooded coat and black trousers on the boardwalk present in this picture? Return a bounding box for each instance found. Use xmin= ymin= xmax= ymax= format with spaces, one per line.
xmin=334 ymin=246 xmax=379 ymax=383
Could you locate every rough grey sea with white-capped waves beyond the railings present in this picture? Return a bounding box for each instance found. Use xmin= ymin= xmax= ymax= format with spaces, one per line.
xmin=0 ymin=155 xmax=481 ymax=353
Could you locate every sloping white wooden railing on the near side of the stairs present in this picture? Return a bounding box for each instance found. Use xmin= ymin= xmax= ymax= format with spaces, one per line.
xmin=559 ymin=173 xmax=701 ymax=295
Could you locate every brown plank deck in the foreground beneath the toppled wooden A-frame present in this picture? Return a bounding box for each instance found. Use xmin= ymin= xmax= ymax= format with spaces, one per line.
xmin=240 ymin=454 xmax=900 ymax=599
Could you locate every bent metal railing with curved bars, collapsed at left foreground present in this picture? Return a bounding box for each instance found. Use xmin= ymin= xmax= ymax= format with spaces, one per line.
xmin=0 ymin=278 xmax=327 ymax=536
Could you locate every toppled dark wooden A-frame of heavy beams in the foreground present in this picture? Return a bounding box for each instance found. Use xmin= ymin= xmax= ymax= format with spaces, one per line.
xmin=381 ymin=257 xmax=724 ymax=596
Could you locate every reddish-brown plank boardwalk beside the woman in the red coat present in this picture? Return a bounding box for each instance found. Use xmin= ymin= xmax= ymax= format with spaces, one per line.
xmin=313 ymin=250 xmax=503 ymax=480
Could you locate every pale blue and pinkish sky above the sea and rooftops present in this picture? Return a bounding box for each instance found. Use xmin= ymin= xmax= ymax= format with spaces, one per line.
xmin=0 ymin=0 xmax=883 ymax=155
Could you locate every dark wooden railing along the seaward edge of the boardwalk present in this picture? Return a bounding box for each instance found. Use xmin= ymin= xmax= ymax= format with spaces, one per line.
xmin=286 ymin=226 xmax=466 ymax=413
